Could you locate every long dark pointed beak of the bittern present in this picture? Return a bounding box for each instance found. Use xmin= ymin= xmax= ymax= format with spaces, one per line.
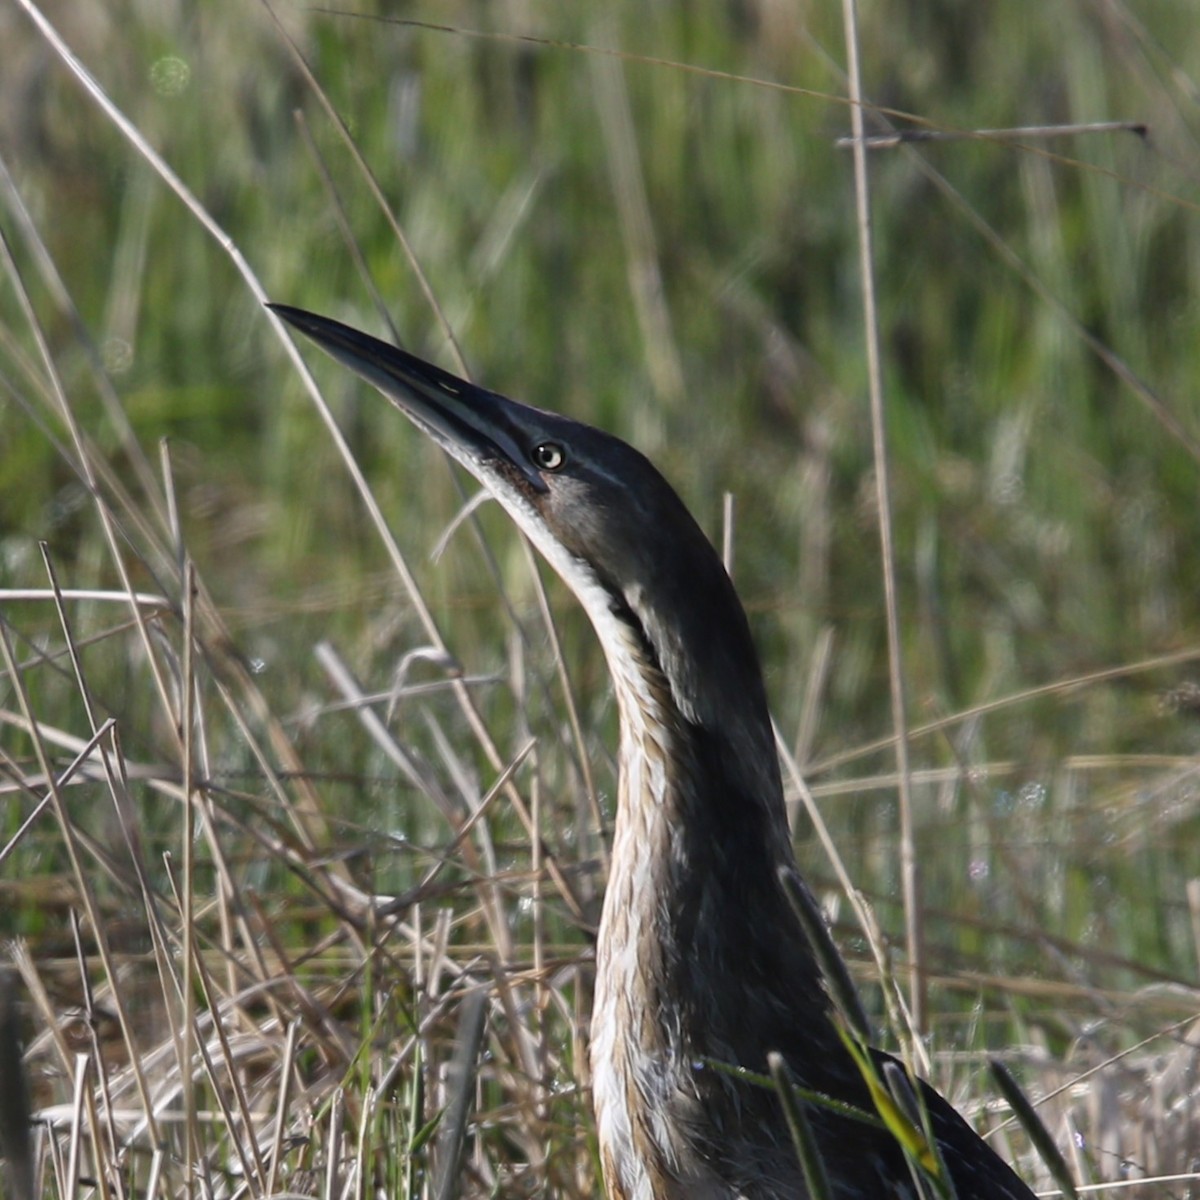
xmin=266 ymin=304 xmax=546 ymax=492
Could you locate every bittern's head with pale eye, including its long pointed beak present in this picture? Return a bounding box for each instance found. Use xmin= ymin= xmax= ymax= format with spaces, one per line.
xmin=270 ymin=305 xmax=774 ymax=744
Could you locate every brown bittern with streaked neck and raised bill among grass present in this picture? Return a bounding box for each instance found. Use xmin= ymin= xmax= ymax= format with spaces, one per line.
xmin=270 ymin=305 xmax=1033 ymax=1200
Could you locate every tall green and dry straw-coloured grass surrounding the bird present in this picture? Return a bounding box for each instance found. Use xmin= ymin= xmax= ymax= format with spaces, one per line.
xmin=0 ymin=0 xmax=1200 ymax=1200
